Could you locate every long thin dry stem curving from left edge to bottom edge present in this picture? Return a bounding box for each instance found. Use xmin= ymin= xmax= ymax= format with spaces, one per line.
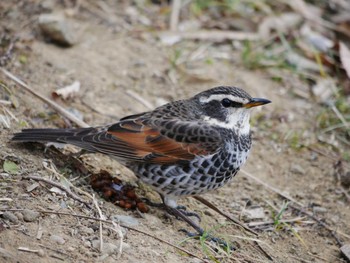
xmin=0 ymin=208 xmax=208 ymax=262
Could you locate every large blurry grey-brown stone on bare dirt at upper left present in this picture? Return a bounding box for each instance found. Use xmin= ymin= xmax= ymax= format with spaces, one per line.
xmin=39 ymin=13 xmax=76 ymax=46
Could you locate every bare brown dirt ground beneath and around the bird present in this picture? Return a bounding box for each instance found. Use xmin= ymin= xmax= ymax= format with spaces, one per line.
xmin=0 ymin=1 xmax=350 ymax=262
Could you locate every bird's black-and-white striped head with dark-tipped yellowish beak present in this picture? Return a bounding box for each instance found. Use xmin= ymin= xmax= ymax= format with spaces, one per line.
xmin=194 ymin=86 xmax=271 ymax=134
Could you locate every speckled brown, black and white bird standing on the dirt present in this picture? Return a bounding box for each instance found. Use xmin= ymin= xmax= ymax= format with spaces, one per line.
xmin=12 ymin=86 xmax=271 ymax=241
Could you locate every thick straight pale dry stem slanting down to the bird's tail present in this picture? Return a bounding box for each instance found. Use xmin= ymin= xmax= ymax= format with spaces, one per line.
xmin=0 ymin=68 xmax=89 ymax=128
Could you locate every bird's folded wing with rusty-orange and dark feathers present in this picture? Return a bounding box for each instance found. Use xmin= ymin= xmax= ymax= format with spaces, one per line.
xmin=100 ymin=118 xmax=221 ymax=163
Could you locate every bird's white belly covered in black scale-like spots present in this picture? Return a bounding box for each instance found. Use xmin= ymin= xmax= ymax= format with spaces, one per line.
xmin=129 ymin=153 xmax=246 ymax=196
